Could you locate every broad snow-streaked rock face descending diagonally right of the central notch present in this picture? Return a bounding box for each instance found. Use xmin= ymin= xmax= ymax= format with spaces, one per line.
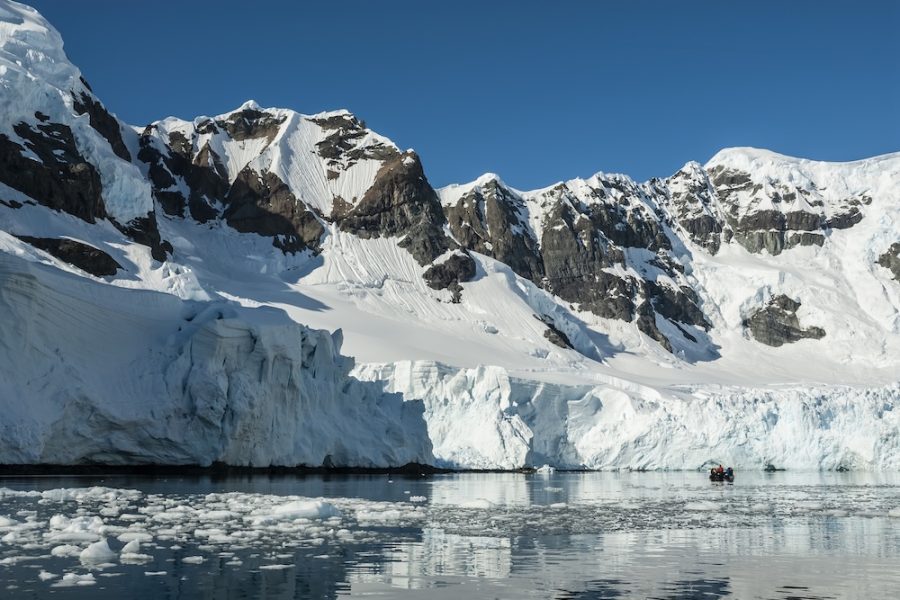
xmin=442 ymin=175 xmax=710 ymax=351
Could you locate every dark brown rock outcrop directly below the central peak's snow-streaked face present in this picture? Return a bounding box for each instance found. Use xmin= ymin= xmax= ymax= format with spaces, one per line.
xmin=224 ymin=166 xmax=325 ymax=252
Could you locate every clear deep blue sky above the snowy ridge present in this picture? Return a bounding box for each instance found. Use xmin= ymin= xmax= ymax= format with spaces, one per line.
xmin=31 ymin=0 xmax=900 ymax=189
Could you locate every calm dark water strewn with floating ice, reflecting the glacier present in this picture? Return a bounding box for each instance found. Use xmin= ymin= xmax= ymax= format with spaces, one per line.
xmin=0 ymin=472 xmax=900 ymax=599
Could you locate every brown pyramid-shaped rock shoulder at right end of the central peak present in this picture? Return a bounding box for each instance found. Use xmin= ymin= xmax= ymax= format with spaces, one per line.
xmin=336 ymin=154 xmax=455 ymax=265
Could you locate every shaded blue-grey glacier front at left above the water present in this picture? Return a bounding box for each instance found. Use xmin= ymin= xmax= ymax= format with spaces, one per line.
xmin=0 ymin=254 xmax=433 ymax=467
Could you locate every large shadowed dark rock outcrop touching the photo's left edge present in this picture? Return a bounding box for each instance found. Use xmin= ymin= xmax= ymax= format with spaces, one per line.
xmin=0 ymin=123 xmax=106 ymax=223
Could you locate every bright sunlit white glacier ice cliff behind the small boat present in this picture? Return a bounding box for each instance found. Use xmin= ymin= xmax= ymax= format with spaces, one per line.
xmin=355 ymin=361 xmax=900 ymax=471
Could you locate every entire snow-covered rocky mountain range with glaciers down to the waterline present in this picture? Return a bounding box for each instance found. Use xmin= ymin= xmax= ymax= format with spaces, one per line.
xmin=0 ymin=0 xmax=900 ymax=469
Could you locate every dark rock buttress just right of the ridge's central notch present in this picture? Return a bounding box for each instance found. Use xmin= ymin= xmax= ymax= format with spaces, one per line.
xmin=444 ymin=181 xmax=544 ymax=282
